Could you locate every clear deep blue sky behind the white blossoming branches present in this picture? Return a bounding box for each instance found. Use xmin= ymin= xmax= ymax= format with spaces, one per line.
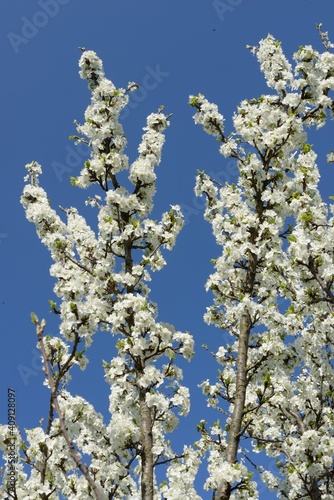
xmin=0 ymin=0 xmax=334 ymax=500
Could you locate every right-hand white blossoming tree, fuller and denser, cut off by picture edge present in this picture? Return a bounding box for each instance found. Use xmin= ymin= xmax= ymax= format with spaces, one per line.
xmin=190 ymin=25 xmax=334 ymax=500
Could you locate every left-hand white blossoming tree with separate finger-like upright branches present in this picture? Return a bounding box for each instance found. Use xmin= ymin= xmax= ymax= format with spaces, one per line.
xmin=2 ymin=49 xmax=198 ymax=500
